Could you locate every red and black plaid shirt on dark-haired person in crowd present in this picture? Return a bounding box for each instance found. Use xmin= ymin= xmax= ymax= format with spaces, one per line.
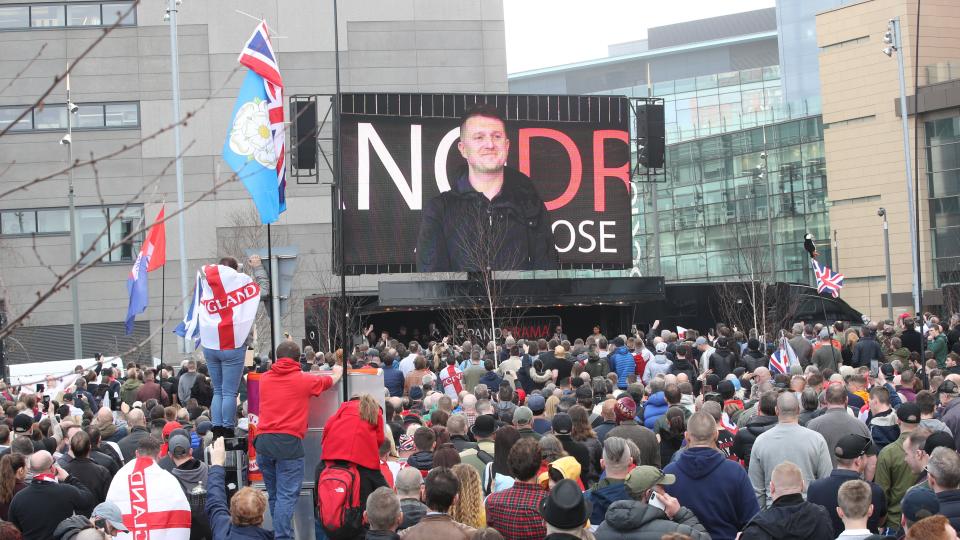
xmin=487 ymin=482 xmax=547 ymax=540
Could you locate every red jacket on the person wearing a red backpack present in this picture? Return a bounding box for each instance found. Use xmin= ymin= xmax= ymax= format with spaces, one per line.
xmin=320 ymin=399 xmax=383 ymax=469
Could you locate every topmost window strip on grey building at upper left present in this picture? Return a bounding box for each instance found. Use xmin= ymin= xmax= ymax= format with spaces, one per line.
xmin=0 ymin=2 xmax=137 ymax=30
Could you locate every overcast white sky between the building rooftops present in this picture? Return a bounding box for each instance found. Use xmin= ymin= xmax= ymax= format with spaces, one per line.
xmin=503 ymin=0 xmax=774 ymax=73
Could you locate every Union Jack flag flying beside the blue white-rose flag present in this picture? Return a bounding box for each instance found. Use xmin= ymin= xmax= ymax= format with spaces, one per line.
xmin=238 ymin=22 xmax=287 ymax=213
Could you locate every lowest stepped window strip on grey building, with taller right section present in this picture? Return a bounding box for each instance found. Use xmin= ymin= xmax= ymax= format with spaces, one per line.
xmin=0 ymin=206 xmax=143 ymax=263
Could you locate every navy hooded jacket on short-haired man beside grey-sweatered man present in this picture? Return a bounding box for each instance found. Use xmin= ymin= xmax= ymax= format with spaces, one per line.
xmin=663 ymin=446 xmax=760 ymax=540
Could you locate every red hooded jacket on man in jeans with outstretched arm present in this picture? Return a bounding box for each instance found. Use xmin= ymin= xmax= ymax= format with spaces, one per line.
xmin=257 ymin=358 xmax=333 ymax=439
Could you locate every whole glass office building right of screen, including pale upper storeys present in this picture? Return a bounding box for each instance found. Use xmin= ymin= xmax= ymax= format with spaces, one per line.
xmin=605 ymin=66 xmax=831 ymax=283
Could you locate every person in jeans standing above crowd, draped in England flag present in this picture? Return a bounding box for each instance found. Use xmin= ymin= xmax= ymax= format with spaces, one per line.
xmin=174 ymin=255 xmax=270 ymax=437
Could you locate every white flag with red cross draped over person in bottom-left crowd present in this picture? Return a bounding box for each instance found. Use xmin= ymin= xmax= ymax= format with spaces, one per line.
xmin=107 ymin=458 xmax=190 ymax=540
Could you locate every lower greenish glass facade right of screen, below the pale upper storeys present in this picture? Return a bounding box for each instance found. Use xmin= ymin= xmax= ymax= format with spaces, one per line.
xmin=634 ymin=116 xmax=831 ymax=283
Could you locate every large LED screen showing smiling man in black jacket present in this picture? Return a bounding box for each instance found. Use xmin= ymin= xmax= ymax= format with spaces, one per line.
xmin=340 ymin=94 xmax=632 ymax=273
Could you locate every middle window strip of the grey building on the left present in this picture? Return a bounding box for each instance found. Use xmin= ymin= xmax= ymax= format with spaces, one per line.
xmin=0 ymin=102 xmax=140 ymax=132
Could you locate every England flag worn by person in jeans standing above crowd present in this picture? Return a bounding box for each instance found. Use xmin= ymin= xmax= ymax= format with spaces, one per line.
xmin=173 ymin=264 xmax=260 ymax=351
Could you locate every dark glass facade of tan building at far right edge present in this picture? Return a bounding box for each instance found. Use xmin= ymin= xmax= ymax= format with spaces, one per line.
xmin=924 ymin=117 xmax=960 ymax=286
